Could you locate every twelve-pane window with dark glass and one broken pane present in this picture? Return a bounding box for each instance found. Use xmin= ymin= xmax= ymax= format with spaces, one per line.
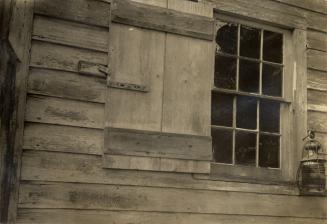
xmin=211 ymin=21 xmax=284 ymax=168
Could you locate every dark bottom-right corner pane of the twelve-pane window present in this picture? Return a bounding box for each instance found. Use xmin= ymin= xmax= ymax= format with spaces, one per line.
xmin=259 ymin=135 xmax=280 ymax=168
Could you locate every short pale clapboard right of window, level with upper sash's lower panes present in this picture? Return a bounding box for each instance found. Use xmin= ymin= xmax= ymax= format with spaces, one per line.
xmin=308 ymin=69 xmax=327 ymax=91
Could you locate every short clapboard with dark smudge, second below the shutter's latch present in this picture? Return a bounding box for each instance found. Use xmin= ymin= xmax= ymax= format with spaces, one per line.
xmin=25 ymin=95 xmax=104 ymax=129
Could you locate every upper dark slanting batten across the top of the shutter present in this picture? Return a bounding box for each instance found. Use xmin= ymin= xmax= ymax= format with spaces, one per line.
xmin=111 ymin=0 xmax=214 ymax=41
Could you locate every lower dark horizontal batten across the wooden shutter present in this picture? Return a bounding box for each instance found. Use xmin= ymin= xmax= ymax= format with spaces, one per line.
xmin=105 ymin=128 xmax=212 ymax=161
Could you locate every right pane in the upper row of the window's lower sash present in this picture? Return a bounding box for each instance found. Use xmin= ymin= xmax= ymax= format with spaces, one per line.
xmin=259 ymin=100 xmax=280 ymax=133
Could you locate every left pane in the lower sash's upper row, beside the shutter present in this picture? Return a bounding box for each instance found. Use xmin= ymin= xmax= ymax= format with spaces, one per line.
xmin=211 ymin=92 xmax=233 ymax=127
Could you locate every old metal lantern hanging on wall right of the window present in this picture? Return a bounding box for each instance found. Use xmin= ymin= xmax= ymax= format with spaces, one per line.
xmin=297 ymin=131 xmax=327 ymax=195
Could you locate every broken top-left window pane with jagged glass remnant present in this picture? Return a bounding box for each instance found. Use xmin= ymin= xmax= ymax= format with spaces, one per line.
xmin=216 ymin=21 xmax=237 ymax=55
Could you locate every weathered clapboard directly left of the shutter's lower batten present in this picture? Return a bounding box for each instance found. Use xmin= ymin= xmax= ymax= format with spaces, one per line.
xmin=22 ymin=122 xmax=104 ymax=155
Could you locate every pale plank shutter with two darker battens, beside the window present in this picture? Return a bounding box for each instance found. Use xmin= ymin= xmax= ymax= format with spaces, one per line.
xmin=104 ymin=0 xmax=214 ymax=173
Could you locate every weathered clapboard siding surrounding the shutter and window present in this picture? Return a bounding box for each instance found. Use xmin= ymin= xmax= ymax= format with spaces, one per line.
xmin=17 ymin=0 xmax=327 ymax=224
